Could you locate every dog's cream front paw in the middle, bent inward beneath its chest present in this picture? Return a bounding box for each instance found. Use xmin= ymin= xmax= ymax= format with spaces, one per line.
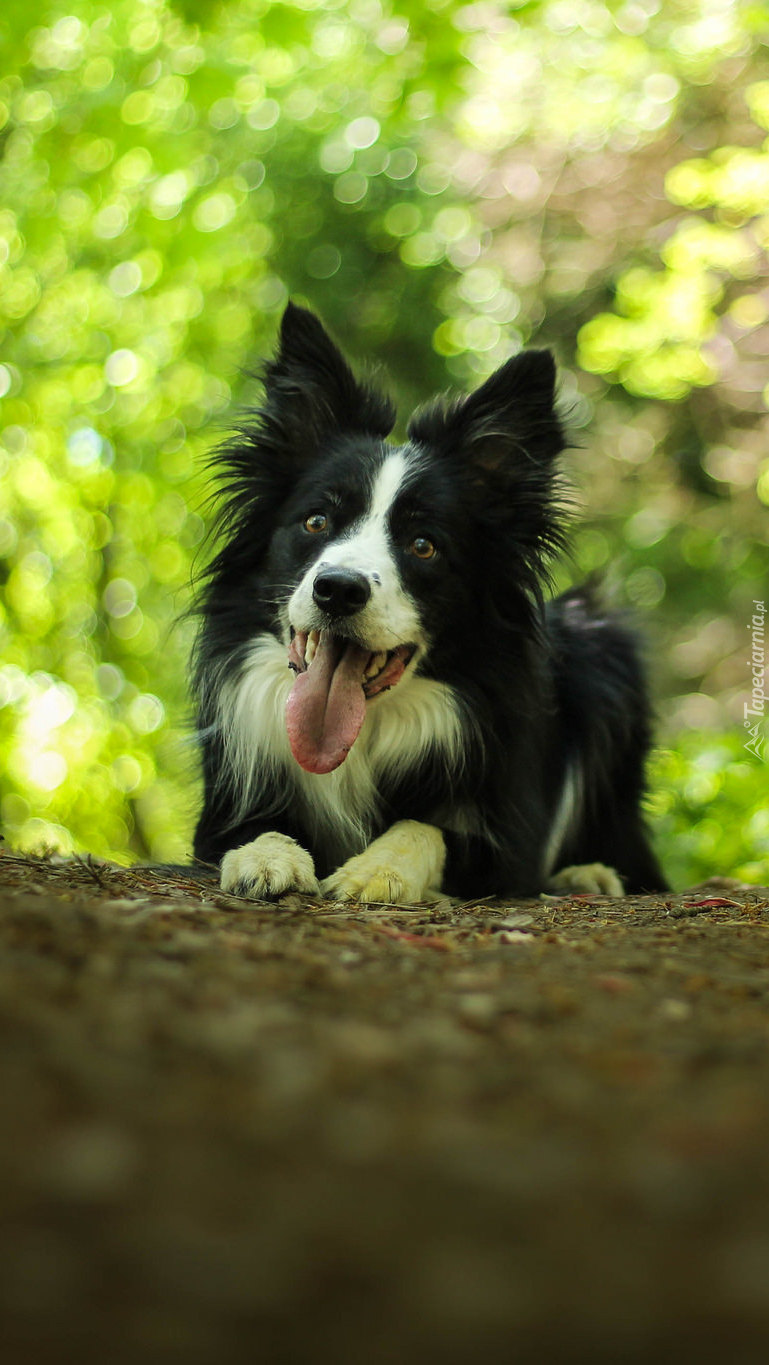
xmin=322 ymin=820 xmax=445 ymax=905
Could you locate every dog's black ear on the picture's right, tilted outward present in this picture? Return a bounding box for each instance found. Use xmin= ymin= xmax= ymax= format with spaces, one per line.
xmin=408 ymin=351 xmax=565 ymax=476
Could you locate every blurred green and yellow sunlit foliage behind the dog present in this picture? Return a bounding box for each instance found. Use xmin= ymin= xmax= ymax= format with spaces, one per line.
xmin=0 ymin=0 xmax=769 ymax=886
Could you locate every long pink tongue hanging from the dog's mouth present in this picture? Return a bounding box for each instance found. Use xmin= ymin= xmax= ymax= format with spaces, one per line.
xmin=285 ymin=631 xmax=370 ymax=773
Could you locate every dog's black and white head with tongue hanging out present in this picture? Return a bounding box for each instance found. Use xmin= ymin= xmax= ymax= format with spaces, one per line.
xmin=210 ymin=304 xmax=563 ymax=773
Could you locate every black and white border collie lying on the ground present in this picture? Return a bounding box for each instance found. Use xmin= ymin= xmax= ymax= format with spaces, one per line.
xmin=195 ymin=306 xmax=665 ymax=904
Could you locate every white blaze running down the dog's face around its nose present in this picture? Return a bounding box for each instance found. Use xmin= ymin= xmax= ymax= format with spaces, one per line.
xmin=288 ymin=450 xmax=422 ymax=650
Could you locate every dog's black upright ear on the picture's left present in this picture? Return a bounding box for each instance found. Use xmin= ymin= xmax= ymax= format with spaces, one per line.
xmin=262 ymin=303 xmax=395 ymax=459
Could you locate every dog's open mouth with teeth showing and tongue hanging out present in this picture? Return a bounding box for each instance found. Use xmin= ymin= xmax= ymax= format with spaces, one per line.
xmin=285 ymin=631 xmax=417 ymax=773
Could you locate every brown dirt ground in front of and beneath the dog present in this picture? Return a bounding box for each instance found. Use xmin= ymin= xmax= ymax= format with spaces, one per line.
xmin=0 ymin=853 xmax=769 ymax=1365
